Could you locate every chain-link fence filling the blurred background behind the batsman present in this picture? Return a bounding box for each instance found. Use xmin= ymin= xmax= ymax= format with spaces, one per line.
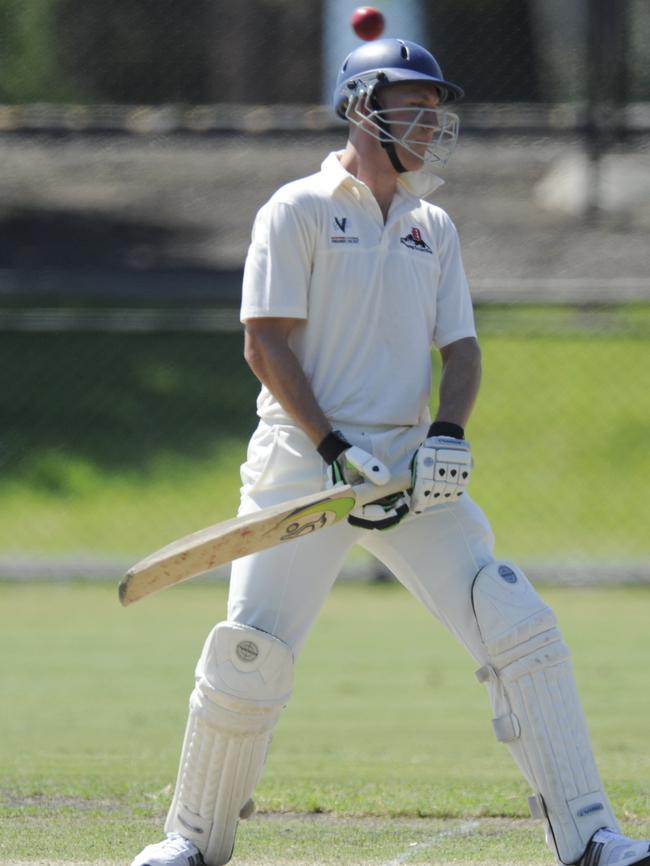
xmin=0 ymin=0 xmax=650 ymax=578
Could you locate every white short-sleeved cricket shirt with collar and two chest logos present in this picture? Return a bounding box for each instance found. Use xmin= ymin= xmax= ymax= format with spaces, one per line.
xmin=241 ymin=153 xmax=476 ymax=426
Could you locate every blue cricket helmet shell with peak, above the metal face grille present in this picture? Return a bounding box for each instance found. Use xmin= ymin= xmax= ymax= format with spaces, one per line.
xmin=334 ymin=39 xmax=464 ymax=117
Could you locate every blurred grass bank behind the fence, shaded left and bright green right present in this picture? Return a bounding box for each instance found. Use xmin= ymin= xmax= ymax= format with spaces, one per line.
xmin=0 ymin=306 xmax=650 ymax=564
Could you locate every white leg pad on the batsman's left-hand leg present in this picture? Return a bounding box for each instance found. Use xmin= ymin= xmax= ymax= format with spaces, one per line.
xmin=165 ymin=622 xmax=293 ymax=866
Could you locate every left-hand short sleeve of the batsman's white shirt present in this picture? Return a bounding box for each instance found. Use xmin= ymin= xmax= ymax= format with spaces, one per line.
xmin=240 ymin=199 xmax=313 ymax=322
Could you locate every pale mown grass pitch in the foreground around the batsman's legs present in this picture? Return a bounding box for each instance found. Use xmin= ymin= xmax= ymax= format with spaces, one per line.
xmin=0 ymin=584 xmax=650 ymax=866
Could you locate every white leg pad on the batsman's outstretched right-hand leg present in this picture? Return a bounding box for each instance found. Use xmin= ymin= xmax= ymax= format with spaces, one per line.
xmin=472 ymin=562 xmax=617 ymax=863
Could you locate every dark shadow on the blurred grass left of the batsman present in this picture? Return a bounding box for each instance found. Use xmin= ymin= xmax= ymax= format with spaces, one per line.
xmin=0 ymin=333 xmax=259 ymax=479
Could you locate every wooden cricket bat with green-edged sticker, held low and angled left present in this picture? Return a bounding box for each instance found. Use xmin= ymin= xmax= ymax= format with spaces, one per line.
xmin=119 ymin=475 xmax=411 ymax=607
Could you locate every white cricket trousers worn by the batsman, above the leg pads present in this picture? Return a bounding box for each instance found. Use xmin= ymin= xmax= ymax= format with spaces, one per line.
xmin=228 ymin=422 xmax=494 ymax=664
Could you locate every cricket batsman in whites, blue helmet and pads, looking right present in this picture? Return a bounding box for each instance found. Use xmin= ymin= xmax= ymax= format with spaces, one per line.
xmin=133 ymin=39 xmax=650 ymax=866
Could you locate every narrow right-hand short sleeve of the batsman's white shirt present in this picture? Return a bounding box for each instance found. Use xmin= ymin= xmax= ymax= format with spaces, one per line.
xmin=433 ymin=215 xmax=476 ymax=349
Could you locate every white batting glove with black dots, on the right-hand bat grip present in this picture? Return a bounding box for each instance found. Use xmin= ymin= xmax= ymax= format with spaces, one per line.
xmin=411 ymin=436 xmax=473 ymax=513
